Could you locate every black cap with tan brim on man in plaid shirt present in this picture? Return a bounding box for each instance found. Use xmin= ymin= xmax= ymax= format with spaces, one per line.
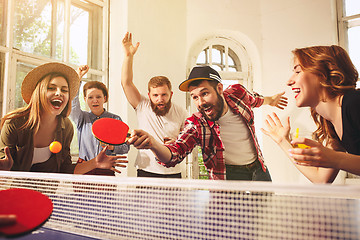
xmin=179 ymin=66 xmax=221 ymax=92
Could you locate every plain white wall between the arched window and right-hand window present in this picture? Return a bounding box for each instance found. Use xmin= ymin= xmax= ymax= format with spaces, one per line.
xmin=258 ymin=0 xmax=346 ymax=182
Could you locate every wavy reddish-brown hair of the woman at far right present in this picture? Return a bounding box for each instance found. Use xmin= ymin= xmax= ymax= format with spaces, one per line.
xmin=293 ymin=45 xmax=359 ymax=144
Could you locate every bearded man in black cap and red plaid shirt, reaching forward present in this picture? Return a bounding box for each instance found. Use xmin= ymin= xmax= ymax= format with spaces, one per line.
xmin=129 ymin=66 xmax=287 ymax=181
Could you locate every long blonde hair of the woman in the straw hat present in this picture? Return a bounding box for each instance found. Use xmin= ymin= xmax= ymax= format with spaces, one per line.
xmin=1 ymin=73 xmax=71 ymax=133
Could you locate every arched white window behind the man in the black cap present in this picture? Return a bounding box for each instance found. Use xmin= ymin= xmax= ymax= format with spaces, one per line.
xmin=187 ymin=36 xmax=253 ymax=179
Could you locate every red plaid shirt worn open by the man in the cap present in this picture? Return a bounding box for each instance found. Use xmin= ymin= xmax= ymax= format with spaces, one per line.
xmin=165 ymin=84 xmax=266 ymax=180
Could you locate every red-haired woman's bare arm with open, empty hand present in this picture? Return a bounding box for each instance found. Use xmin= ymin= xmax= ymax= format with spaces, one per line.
xmin=261 ymin=113 xmax=339 ymax=183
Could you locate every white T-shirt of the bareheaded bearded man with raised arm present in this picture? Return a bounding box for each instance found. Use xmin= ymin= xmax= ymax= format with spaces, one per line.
xmin=135 ymin=96 xmax=188 ymax=174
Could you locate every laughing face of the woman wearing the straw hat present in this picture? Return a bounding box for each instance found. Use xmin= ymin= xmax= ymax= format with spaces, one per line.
xmin=46 ymin=76 xmax=69 ymax=115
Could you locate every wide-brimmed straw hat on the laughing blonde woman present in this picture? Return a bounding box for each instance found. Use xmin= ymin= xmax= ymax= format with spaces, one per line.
xmin=21 ymin=62 xmax=80 ymax=103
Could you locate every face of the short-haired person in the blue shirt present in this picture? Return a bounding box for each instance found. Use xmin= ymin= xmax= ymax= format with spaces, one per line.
xmin=84 ymin=88 xmax=106 ymax=116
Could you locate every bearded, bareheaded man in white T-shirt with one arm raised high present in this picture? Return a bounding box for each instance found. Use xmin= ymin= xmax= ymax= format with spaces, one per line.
xmin=121 ymin=33 xmax=187 ymax=178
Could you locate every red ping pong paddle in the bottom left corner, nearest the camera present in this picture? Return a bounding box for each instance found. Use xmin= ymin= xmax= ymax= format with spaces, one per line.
xmin=0 ymin=188 xmax=53 ymax=236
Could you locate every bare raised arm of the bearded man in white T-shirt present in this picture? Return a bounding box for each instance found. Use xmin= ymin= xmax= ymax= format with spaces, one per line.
xmin=121 ymin=32 xmax=141 ymax=108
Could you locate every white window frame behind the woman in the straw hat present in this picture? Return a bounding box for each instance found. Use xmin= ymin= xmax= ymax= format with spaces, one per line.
xmin=0 ymin=0 xmax=109 ymax=116
